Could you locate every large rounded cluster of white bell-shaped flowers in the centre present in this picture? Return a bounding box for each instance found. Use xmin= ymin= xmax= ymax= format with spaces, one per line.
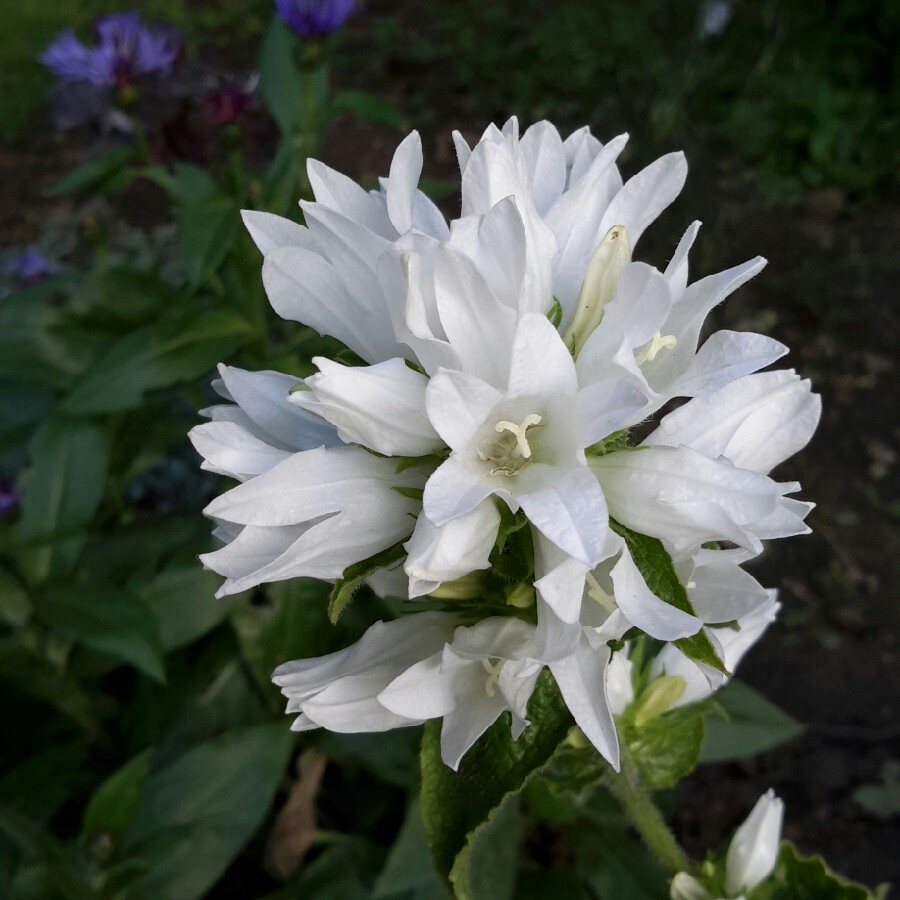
xmin=191 ymin=119 xmax=820 ymax=768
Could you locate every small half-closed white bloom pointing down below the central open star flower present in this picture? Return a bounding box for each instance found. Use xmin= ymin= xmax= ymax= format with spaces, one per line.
xmin=405 ymin=500 xmax=500 ymax=597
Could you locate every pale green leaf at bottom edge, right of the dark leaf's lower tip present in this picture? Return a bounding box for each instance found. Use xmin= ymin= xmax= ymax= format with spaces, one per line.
xmin=450 ymin=793 xmax=521 ymax=900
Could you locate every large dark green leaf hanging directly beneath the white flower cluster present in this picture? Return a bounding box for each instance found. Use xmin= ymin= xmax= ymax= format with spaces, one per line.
xmin=421 ymin=672 xmax=572 ymax=884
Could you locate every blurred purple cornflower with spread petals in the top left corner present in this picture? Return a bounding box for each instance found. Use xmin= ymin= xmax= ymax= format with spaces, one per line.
xmin=38 ymin=12 xmax=181 ymax=88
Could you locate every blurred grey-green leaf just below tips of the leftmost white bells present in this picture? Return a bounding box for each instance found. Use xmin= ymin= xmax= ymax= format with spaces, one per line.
xmin=137 ymin=562 xmax=236 ymax=652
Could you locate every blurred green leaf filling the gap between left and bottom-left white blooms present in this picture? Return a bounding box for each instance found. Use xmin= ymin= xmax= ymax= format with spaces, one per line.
xmin=230 ymin=578 xmax=331 ymax=709
